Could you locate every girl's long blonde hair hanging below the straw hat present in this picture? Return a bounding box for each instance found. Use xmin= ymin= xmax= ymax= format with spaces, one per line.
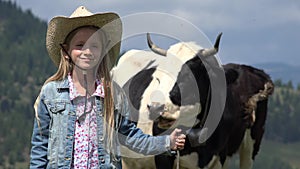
xmin=45 ymin=26 xmax=117 ymax=156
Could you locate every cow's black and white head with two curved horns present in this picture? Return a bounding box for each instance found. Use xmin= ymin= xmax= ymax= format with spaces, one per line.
xmin=145 ymin=34 xmax=222 ymax=129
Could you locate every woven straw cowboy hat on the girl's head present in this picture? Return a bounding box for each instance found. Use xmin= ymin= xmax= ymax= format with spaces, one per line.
xmin=46 ymin=6 xmax=122 ymax=68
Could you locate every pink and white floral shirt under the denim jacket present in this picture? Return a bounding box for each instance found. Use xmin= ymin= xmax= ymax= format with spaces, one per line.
xmin=68 ymin=74 xmax=104 ymax=169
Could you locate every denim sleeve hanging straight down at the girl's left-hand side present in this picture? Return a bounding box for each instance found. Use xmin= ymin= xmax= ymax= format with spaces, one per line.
xmin=30 ymin=96 xmax=50 ymax=169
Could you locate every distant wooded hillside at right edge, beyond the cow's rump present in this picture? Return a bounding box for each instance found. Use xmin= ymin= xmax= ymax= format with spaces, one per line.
xmin=265 ymin=80 xmax=300 ymax=143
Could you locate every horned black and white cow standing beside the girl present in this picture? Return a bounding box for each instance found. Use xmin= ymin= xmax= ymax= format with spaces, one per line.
xmin=112 ymin=33 xmax=272 ymax=169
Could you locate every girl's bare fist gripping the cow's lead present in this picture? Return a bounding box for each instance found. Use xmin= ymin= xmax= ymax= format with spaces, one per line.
xmin=170 ymin=128 xmax=186 ymax=150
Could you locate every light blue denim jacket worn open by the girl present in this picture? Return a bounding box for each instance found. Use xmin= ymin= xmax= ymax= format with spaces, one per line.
xmin=30 ymin=79 xmax=170 ymax=169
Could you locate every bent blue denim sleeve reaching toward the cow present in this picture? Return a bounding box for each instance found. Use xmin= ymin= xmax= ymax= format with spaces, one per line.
xmin=114 ymin=82 xmax=170 ymax=155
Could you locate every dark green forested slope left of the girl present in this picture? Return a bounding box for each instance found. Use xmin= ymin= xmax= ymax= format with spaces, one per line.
xmin=0 ymin=1 xmax=55 ymax=166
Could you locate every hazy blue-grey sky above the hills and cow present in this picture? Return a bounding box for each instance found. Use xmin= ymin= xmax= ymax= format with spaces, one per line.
xmin=11 ymin=0 xmax=300 ymax=66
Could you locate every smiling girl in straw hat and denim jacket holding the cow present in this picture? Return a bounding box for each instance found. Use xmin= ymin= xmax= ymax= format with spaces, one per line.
xmin=30 ymin=7 xmax=185 ymax=169
